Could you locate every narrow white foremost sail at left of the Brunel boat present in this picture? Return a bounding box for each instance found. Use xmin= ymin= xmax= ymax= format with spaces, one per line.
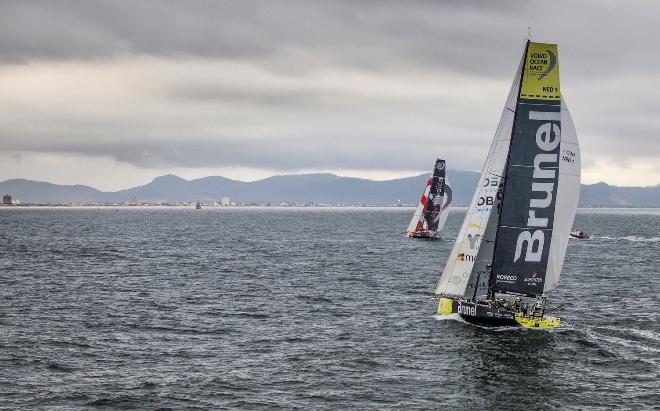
xmin=435 ymin=56 xmax=524 ymax=296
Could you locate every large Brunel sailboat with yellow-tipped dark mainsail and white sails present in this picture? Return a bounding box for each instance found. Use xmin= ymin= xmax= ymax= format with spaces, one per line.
xmin=434 ymin=41 xmax=580 ymax=328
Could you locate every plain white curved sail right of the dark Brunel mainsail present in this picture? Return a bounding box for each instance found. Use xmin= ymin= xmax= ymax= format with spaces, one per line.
xmin=543 ymin=98 xmax=581 ymax=292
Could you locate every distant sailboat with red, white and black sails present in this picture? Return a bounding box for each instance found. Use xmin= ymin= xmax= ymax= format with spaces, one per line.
xmin=406 ymin=159 xmax=451 ymax=239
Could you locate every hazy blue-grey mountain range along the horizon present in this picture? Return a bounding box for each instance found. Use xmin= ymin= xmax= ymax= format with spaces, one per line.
xmin=0 ymin=171 xmax=660 ymax=207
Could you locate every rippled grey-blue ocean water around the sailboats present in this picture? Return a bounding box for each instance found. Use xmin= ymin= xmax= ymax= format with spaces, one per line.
xmin=0 ymin=208 xmax=660 ymax=410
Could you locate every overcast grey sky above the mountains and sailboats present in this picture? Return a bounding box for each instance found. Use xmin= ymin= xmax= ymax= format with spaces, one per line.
xmin=0 ymin=0 xmax=660 ymax=190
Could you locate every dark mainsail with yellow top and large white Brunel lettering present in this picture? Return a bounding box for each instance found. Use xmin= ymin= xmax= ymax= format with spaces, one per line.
xmin=491 ymin=43 xmax=561 ymax=296
